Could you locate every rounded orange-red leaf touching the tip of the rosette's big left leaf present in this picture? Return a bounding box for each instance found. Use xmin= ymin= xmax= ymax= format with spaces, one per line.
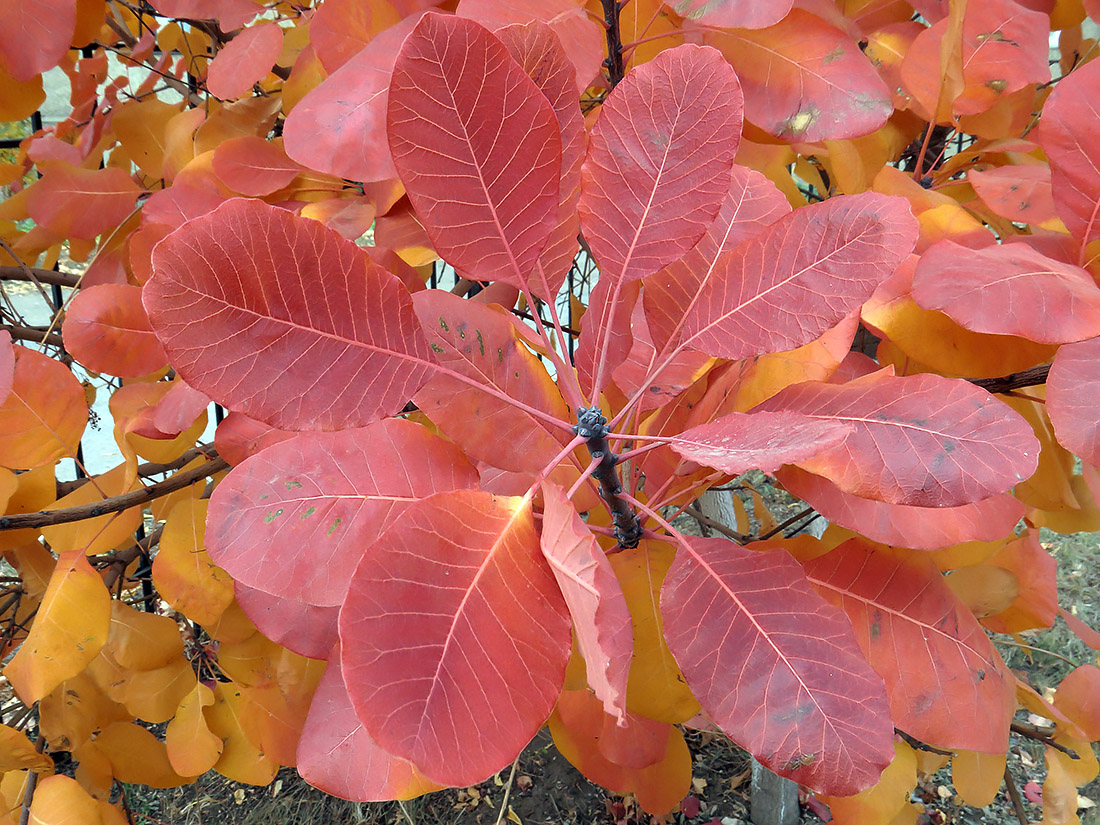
xmin=62 ymin=284 xmax=168 ymax=376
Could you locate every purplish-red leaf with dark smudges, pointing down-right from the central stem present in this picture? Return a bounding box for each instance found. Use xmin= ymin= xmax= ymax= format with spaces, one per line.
xmin=661 ymin=538 xmax=893 ymax=795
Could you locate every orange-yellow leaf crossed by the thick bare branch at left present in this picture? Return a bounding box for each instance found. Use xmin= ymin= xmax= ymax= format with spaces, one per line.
xmin=42 ymin=464 xmax=142 ymax=556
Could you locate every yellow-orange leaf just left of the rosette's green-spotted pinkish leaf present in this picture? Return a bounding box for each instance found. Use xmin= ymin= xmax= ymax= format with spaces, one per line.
xmin=153 ymin=498 xmax=233 ymax=627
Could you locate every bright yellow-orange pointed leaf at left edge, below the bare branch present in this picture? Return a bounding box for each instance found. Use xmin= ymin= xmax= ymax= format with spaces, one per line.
xmin=4 ymin=550 xmax=111 ymax=704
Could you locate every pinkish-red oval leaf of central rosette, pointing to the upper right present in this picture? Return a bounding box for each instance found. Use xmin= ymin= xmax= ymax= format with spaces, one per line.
xmin=681 ymin=194 xmax=917 ymax=359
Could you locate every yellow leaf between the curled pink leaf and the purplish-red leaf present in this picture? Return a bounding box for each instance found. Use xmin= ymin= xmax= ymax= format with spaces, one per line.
xmin=608 ymin=540 xmax=700 ymax=724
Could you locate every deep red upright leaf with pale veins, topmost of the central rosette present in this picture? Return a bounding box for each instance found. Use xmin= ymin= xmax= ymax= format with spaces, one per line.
xmin=387 ymin=13 xmax=561 ymax=286
